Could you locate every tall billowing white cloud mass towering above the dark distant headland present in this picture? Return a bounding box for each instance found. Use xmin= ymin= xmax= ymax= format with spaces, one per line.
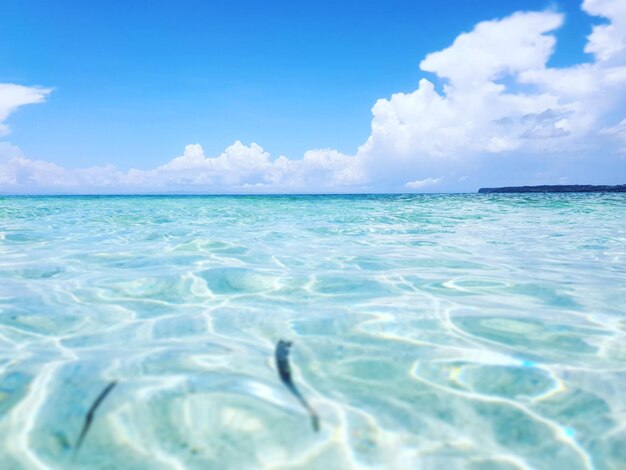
xmin=358 ymin=0 xmax=626 ymax=187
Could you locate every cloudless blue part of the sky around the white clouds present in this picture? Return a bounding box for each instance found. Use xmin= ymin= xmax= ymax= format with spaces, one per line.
xmin=0 ymin=0 xmax=625 ymax=191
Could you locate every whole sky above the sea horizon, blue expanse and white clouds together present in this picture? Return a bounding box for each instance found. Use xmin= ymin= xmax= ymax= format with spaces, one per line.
xmin=0 ymin=0 xmax=626 ymax=194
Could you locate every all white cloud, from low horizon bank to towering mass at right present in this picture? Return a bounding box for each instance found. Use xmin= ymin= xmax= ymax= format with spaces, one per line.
xmin=0 ymin=0 xmax=626 ymax=192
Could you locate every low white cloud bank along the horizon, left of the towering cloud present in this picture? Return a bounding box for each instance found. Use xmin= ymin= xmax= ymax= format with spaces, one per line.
xmin=0 ymin=142 xmax=366 ymax=194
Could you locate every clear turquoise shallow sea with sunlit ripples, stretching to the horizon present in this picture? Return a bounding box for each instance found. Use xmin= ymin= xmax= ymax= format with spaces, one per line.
xmin=0 ymin=194 xmax=626 ymax=469
